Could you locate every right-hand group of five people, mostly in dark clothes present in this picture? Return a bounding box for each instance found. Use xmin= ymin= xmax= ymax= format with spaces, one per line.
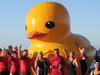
xmin=35 ymin=48 xmax=100 ymax=75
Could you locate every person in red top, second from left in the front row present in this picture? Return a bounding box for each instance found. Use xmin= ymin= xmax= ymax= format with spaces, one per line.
xmin=10 ymin=51 xmax=20 ymax=75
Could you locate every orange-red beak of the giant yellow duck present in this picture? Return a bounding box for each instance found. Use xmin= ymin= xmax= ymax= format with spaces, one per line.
xmin=27 ymin=31 xmax=46 ymax=39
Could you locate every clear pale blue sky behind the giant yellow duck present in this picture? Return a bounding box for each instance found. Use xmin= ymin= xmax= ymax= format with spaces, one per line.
xmin=0 ymin=0 xmax=100 ymax=48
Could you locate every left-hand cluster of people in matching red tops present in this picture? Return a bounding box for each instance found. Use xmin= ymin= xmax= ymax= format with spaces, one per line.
xmin=0 ymin=46 xmax=32 ymax=75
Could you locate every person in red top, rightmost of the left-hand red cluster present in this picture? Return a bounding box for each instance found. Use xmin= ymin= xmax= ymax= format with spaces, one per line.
xmin=20 ymin=50 xmax=32 ymax=75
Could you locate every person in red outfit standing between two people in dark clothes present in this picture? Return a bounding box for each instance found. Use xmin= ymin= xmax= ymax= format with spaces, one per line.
xmin=50 ymin=49 xmax=64 ymax=75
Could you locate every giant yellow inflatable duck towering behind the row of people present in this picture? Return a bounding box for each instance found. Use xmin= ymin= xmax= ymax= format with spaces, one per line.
xmin=26 ymin=2 xmax=94 ymax=75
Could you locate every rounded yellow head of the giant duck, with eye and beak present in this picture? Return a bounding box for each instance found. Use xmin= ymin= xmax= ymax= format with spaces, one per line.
xmin=26 ymin=2 xmax=70 ymax=41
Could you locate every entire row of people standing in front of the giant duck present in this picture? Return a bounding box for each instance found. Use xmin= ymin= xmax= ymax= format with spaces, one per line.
xmin=0 ymin=46 xmax=100 ymax=75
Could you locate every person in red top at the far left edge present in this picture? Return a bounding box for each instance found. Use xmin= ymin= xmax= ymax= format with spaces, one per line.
xmin=0 ymin=50 xmax=10 ymax=75
